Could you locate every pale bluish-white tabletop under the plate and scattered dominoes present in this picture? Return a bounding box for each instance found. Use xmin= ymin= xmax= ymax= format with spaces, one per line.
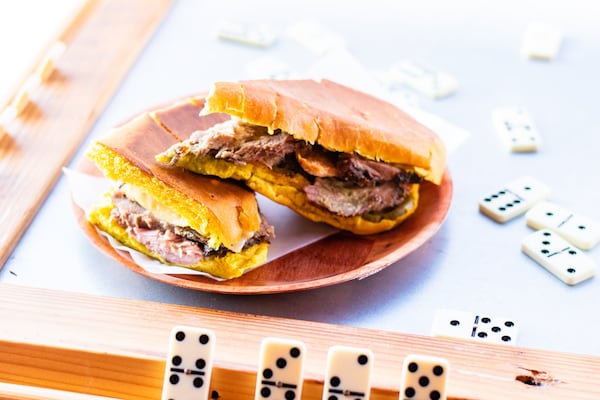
xmin=0 ymin=0 xmax=600 ymax=356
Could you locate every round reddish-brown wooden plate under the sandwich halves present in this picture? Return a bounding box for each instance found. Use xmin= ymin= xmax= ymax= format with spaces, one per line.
xmin=73 ymin=155 xmax=452 ymax=294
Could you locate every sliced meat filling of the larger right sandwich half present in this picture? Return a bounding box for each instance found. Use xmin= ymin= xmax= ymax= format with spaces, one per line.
xmin=164 ymin=119 xmax=422 ymax=221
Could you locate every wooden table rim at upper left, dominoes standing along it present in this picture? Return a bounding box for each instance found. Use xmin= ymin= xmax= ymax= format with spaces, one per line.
xmin=0 ymin=0 xmax=172 ymax=266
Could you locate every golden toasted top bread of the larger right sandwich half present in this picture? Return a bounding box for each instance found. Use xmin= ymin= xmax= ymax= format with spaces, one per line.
xmin=202 ymin=80 xmax=446 ymax=184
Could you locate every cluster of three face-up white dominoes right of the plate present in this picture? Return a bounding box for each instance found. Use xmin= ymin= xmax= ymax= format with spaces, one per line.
xmin=479 ymin=177 xmax=600 ymax=285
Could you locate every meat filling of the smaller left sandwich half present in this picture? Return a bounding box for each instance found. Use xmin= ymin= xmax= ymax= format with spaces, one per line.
xmin=111 ymin=184 xmax=274 ymax=266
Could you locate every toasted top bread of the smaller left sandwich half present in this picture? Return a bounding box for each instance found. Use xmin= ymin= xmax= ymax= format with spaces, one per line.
xmin=87 ymin=109 xmax=260 ymax=250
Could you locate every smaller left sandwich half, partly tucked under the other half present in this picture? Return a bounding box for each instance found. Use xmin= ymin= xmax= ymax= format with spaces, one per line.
xmin=86 ymin=99 xmax=273 ymax=279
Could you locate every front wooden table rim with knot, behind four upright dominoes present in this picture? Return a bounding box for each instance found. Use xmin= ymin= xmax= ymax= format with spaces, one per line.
xmin=0 ymin=284 xmax=600 ymax=400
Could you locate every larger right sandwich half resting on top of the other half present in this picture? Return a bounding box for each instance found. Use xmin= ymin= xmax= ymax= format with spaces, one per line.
xmin=157 ymin=80 xmax=446 ymax=234
